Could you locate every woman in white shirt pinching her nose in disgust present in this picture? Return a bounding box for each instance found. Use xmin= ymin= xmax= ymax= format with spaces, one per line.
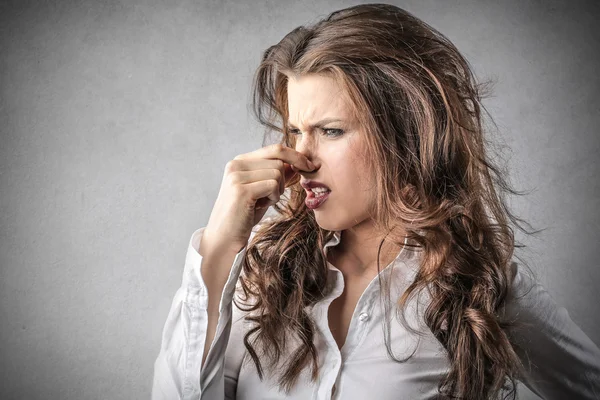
xmin=153 ymin=4 xmax=600 ymax=399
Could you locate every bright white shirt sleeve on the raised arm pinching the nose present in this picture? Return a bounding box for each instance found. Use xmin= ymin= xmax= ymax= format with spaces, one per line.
xmin=152 ymin=225 xmax=258 ymax=400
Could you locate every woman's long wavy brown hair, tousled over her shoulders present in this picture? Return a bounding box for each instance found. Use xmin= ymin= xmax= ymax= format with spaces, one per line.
xmin=236 ymin=4 xmax=535 ymax=399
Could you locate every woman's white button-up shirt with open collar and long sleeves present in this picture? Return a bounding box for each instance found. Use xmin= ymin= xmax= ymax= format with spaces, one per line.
xmin=152 ymin=224 xmax=600 ymax=400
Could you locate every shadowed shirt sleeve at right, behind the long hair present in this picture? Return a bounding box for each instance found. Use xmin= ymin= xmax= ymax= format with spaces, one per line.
xmin=505 ymin=262 xmax=600 ymax=400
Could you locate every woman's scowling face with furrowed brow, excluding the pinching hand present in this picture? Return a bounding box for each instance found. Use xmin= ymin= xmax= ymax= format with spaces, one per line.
xmin=287 ymin=74 xmax=375 ymax=231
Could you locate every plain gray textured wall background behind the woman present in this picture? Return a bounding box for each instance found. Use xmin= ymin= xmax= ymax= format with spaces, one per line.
xmin=0 ymin=0 xmax=600 ymax=399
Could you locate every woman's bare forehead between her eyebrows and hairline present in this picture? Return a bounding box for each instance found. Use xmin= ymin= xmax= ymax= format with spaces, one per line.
xmin=287 ymin=74 xmax=351 ymax=125
